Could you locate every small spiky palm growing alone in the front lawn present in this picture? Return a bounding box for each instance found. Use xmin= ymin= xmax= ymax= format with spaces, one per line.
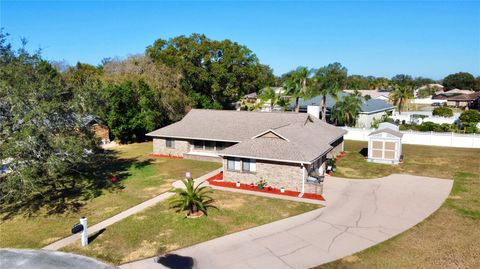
xmin=170 ymin=178 xmax=217 ymax=215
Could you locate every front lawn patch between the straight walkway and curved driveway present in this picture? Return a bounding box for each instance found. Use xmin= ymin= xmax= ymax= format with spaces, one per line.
xmin=62 ymin=191 xmax=319 ymax=264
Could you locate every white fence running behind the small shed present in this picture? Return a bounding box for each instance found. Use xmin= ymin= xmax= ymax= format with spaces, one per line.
xmin=342 ymin=127 xmax=480 ymax=148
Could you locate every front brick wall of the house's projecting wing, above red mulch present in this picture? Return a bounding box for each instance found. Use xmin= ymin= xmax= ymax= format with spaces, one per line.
xmin=223 ymin=158 xmax=307 ymax=191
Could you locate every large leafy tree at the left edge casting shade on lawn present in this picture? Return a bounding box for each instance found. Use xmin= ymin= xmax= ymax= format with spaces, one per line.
xmin=0 ymin=33 xmax=111 ymax=213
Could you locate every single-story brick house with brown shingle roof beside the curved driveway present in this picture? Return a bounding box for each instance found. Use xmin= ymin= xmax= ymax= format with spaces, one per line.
xmin=147 ymin=109 xmax=346 ymax=193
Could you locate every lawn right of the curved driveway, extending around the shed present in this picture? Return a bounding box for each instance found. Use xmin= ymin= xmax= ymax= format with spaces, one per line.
xmin=318 ymin=141 xmax=480 ymax=268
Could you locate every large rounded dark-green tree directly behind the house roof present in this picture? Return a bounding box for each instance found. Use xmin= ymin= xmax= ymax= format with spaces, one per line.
xmin=146 ymin=34 xmax=275 ymax=108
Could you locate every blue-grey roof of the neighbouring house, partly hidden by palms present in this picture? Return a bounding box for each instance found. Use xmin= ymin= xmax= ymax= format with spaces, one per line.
xmin=291 ymin=92 xmax=395 ymax=114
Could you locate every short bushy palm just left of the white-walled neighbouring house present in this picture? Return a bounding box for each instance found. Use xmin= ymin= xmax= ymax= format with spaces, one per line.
xmin=331 ymin=94 xmax=363 ymax=126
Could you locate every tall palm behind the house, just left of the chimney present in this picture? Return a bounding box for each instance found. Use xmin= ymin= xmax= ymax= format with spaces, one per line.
xmin=283 ymin=66 xmax=313 ymax=113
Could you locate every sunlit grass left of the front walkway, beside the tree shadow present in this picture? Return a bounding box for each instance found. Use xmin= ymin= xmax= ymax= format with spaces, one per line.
xmin=0 ymin=143 xmax=220 ymax=248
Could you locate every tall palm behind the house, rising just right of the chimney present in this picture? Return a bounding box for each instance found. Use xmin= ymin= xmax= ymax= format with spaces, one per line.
xmin=314 ymin=63 xmax=348 ymax=121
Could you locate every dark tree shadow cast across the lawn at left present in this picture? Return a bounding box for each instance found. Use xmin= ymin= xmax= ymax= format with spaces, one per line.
xmin=0 ymin=151 xmax=151 ymax=220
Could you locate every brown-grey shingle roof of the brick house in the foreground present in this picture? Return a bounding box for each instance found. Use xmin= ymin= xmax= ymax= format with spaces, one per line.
xmin=147 ymin=109 xmax=346 ymax=162
